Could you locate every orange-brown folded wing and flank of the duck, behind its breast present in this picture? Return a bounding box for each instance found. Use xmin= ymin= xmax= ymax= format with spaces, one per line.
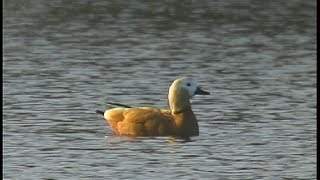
xmin=104 ymin=107 xmax=175 ymax=136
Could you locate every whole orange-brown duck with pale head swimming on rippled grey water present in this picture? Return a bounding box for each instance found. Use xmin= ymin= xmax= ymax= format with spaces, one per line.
xmin=96 ymin=77 xmax=210 ymax=137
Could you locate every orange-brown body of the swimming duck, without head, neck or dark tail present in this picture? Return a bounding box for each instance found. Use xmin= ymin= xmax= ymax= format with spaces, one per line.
xmin=105 ymin=108 xmax=199 ymax=136
